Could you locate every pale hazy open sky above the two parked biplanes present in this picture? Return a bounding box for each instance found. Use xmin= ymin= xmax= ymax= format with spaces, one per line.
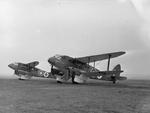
xmin=0 ymin=0 xmax=150 ymax=78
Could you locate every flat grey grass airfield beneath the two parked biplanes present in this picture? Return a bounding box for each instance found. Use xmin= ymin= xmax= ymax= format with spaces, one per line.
xmin=0 ymin=78 xmax=150 ymax=113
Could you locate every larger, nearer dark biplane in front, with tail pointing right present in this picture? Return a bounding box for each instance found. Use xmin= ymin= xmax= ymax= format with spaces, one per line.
xmin=48 ymin=51 xmax=127 ymax=83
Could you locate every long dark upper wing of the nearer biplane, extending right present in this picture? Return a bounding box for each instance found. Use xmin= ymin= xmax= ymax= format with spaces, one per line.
xmin=76 ymin=51 xmax=125 ymax=63
